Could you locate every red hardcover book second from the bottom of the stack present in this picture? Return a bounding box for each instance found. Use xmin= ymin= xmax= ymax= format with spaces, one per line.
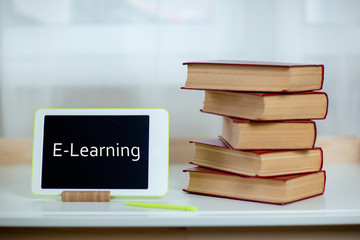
xmin=190 ymin=139 xmax=323 ymax=177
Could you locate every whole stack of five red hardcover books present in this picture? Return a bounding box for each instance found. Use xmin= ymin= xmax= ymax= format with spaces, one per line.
xmin=183 ymin=61 xmax=328 ymax=204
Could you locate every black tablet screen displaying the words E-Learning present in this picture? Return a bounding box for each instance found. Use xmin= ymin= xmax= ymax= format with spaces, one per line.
xmin=41 ymin=115 xmax=150 ymax=189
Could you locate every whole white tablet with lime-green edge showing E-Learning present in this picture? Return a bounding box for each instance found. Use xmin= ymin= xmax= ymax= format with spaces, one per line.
xmin=32 ymin=109 xmax=169 ymax=196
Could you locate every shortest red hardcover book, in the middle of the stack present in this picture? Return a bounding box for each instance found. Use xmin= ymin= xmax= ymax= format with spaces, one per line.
xmin=222 ymin=117 xmax=316 ymax=150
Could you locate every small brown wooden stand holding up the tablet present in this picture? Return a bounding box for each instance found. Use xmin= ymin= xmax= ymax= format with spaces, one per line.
xmin=61 ymin=191 xmax=111 ymax=202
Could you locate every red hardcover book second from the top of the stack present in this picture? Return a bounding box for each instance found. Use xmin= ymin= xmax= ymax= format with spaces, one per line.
xmin=202 ymin=90 xmax=328 ymax=121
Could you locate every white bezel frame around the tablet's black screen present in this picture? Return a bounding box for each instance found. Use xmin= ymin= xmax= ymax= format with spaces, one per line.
xmin=31 ymin=108 xmax=169 ymax=196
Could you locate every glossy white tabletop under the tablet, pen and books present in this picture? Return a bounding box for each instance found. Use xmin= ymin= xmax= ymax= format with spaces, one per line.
xmin=0 ymin=163 xmax=360 ymax=227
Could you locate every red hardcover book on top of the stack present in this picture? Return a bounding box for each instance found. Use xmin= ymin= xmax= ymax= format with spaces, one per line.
xmin=183 ymin=60 xmax=324 ymax=92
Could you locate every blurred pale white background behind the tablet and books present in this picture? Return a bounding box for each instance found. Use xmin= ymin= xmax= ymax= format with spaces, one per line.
xmin=0 ymin=0 xmax=360 ymax=137
